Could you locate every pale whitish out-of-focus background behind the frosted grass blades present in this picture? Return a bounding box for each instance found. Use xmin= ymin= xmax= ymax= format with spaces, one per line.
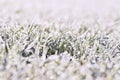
xmin=0 ymin=0 xmax=120 ymax=27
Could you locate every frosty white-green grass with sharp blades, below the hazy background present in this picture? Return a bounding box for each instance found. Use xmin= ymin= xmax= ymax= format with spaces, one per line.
xmin=0 ymin=24 xmax=120 ymax=80
